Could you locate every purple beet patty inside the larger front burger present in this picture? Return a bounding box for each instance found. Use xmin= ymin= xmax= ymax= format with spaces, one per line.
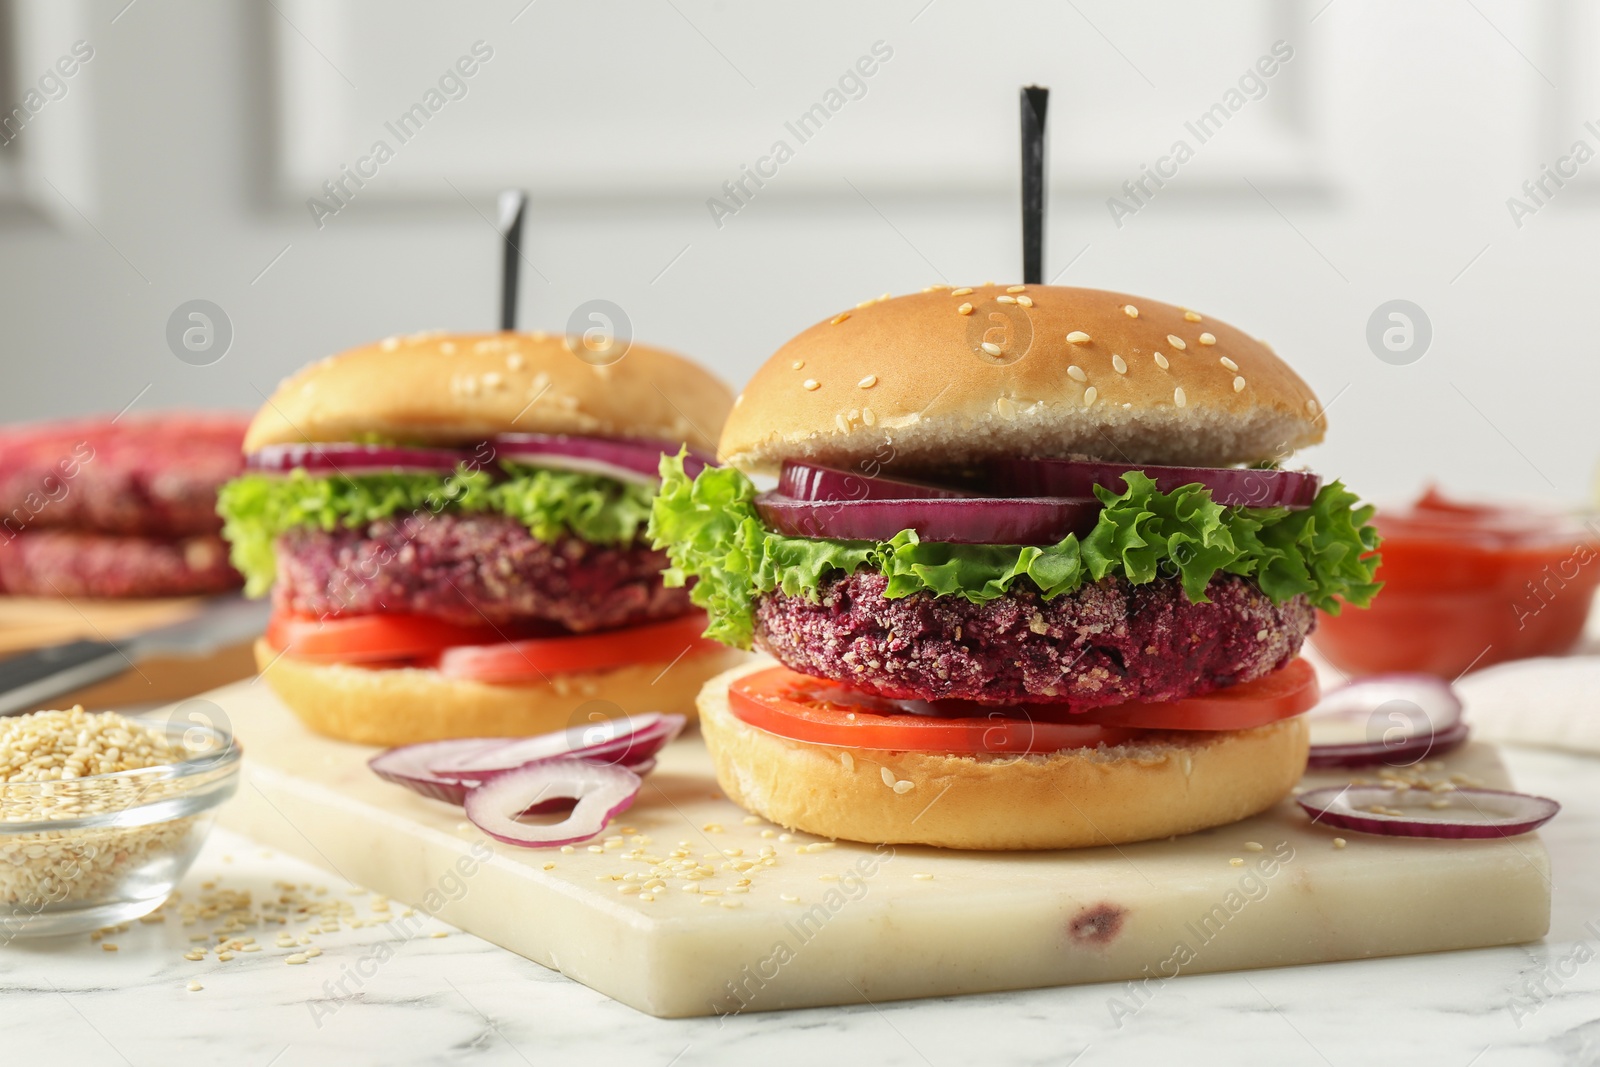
xmin=755 ymin=571 xmax=1315 ymax=709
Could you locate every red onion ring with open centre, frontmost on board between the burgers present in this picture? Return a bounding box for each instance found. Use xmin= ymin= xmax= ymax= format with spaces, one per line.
xmin=464 ymin=757 xmax=643 ymax=848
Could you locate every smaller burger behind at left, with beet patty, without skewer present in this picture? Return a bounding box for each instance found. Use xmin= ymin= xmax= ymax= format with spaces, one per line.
xmin=219 ymin=333 xmax=738 ymax=745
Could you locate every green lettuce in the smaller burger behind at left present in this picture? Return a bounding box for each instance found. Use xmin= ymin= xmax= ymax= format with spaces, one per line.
xmin=218 ymin=464 xmax=654 ymax=597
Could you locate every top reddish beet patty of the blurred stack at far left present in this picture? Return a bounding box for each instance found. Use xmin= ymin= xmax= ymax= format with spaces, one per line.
xmin=0 ymin=413 xmax=250 ymax=537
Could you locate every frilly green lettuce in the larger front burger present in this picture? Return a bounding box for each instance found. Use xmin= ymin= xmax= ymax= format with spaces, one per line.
xmin=646 ymin=456 xmax=1379 ymax=648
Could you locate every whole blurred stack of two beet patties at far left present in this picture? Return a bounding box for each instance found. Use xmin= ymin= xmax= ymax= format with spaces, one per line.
xmin=0 ymin=413 xmax=248 ymax=597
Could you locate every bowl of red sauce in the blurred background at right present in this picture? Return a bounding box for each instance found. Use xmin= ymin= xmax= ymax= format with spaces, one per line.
xmin=1312 ymin=488 xmax=1600 ymax=678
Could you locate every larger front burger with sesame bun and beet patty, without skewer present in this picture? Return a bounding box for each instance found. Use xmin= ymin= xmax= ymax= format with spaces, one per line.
xmin=650 ymin=285 xmax=1378 ymax=849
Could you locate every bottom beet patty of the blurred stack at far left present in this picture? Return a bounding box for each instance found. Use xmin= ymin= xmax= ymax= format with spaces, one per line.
xmin=0 ymin=530 xmax=243 ymax=597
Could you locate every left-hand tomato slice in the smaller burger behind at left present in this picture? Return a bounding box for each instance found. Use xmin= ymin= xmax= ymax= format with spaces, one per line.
xmin=267 ymin=611 xmax=506 ymax=662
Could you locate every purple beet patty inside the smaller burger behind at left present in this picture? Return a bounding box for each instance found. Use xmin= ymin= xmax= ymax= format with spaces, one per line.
xmin=272 ymin=514 xmax=690 ymax=630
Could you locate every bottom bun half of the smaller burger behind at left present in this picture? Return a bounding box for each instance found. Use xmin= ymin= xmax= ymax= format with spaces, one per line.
xmin=256 ymin=638 xmax=747 ymax=747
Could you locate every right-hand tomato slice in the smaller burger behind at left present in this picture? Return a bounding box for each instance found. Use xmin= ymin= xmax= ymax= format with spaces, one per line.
xmin=438 ymin=611 xmax=720 ymax=685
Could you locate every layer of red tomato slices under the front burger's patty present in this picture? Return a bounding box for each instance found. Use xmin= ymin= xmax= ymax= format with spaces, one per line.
xmin=728 ymin=659 xmax=1318 ymax=755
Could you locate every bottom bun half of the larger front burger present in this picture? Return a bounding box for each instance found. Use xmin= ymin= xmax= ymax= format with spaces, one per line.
xmin=699 ymin=662 xmax=1310 ymax=849
